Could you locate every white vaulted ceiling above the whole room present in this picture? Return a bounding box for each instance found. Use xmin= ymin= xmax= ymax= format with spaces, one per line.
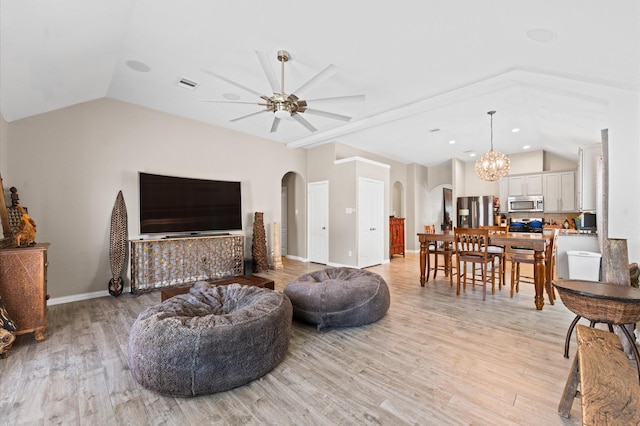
xmin=0 ymin=0 xmax=640 ymax=166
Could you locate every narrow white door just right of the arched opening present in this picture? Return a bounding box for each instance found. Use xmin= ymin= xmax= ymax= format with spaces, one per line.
xmin=307 ymin=181 xmax=329 ymax=264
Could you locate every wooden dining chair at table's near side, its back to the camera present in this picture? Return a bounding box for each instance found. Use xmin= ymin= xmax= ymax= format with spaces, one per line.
xmin=453 ymin=228 xmax=496 ymax=300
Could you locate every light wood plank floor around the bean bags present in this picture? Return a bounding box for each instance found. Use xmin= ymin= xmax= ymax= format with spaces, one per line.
xmin=0 ymin=253 xmax=608 ymax=425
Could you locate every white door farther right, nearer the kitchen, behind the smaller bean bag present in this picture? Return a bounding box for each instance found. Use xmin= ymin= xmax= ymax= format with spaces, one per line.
xmin=357 ymin=178 xmax=384 ymax=268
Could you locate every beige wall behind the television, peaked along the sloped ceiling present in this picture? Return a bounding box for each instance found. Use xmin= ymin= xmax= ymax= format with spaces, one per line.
xmin=3 ymin=99 xmax=306 ymax=298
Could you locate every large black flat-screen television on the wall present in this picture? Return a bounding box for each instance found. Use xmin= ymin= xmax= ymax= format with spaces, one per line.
xmin=139 ymin=172 xmax=242 ymax=234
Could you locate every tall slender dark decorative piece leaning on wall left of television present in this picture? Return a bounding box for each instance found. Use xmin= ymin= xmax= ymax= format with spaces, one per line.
xmin=109 ymin=191 xmax=127 ymax=297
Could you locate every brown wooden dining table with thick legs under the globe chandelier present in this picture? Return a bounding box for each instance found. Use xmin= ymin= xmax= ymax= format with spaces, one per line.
xmin=418 ymin=231 xmax=553 ymax=310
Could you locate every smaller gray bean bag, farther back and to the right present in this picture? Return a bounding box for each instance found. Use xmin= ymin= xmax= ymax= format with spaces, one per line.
xmin=284 ymin=268 xmax=390 ymax=330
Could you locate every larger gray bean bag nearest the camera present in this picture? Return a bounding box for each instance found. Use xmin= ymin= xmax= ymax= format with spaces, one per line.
xmin=128 ymin=282 xmax=292 ymax=396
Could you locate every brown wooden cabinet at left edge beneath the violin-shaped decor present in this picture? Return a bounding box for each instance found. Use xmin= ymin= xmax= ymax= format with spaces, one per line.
xmin=0 ymin=243 xmax=49 ymax=341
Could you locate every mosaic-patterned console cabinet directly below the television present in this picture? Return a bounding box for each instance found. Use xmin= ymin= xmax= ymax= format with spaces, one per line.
xmin=130 ymin=235 xmax=244 ymax=293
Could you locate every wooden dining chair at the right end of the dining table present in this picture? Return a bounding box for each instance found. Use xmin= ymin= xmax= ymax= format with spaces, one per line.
xmin=505 ymin=229 xmax=559 ymax=305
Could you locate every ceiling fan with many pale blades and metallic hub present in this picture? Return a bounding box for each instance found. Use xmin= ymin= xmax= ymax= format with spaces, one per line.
xmin=200 ymin=50 xmax=365 ymax=133
